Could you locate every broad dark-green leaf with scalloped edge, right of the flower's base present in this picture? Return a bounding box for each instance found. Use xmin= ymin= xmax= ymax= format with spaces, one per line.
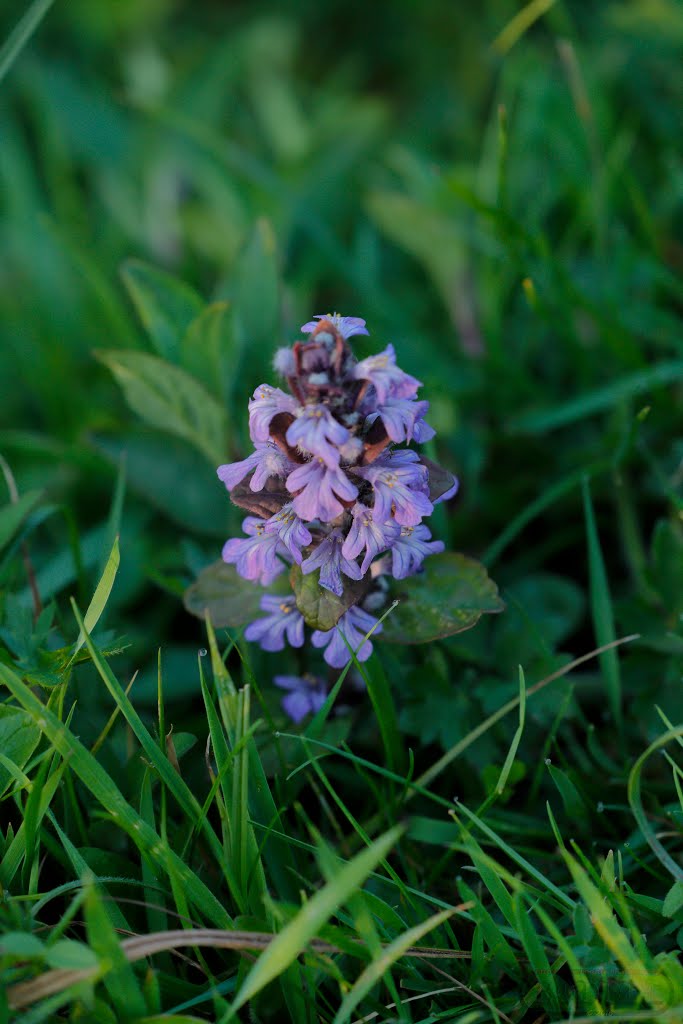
xmin=378 ymin=552 xmax=505 ymax=643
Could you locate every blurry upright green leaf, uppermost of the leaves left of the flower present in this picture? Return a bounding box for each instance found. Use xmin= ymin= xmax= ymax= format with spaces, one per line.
xmin=121 ymin=260 xmax=204 ymax=362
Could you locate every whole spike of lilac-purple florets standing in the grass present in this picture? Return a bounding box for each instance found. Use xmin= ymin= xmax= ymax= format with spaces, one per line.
xmin=218 ymin=315 xmax=458 ymax=679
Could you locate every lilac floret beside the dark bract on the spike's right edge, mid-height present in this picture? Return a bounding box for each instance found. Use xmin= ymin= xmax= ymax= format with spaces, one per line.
xmin=353 ymin=451 xmax=434 ymax=526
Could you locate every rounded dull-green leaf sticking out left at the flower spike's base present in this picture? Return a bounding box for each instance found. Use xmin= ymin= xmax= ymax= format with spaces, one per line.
xmin=183 ymin=561 xmax=289 ymax=629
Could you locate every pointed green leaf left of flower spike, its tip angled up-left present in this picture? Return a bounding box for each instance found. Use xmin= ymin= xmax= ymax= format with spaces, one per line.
xmin=95 ymin=350 xmax=226 ymax=466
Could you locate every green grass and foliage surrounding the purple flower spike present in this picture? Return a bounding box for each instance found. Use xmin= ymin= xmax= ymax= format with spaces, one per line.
xmin=0 ymin=0 xmax=683 ymax=1024
